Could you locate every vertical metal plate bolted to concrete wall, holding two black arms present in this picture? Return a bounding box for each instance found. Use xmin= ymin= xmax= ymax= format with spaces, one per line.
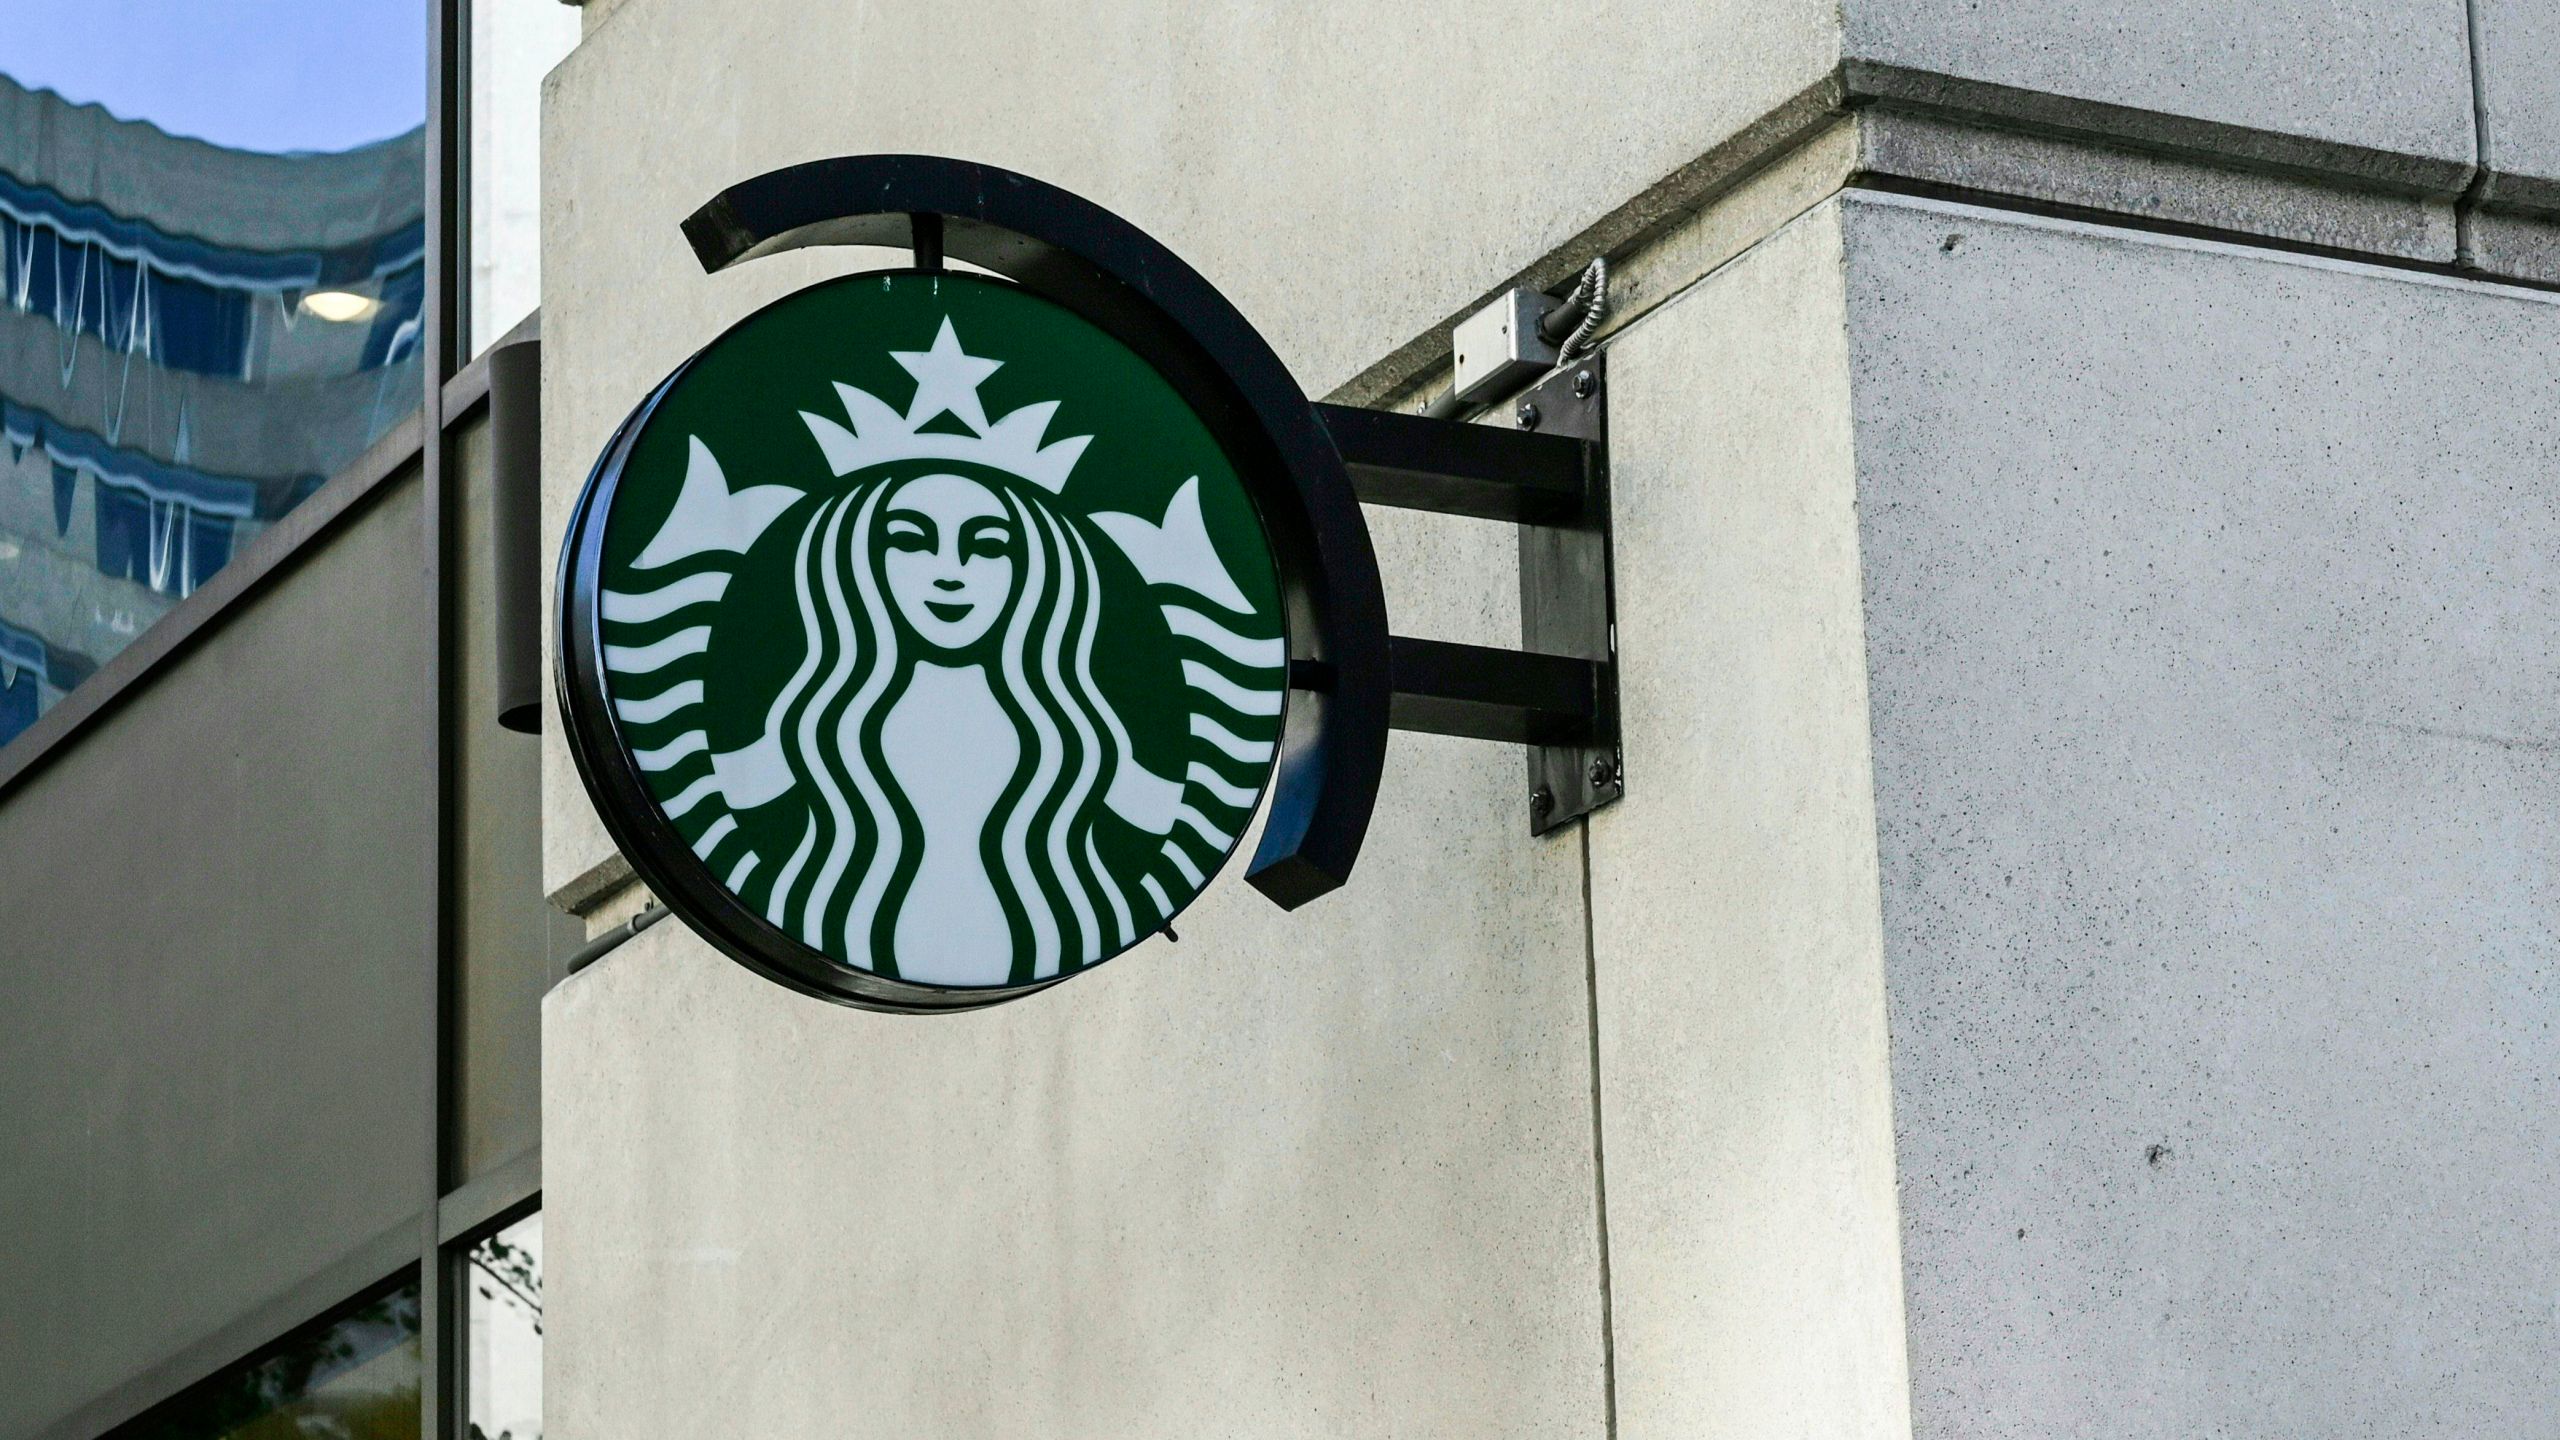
xmin=1510 ymin=354 xmax=1626 ymax=835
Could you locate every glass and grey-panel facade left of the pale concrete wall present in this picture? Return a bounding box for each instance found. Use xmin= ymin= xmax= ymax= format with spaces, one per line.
xmin=0 ymin=0 xmax=579 ymax=1440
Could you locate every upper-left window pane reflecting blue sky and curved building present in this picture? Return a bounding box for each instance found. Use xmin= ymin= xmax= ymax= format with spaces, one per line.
xmin=0 ymin=0 xmax=425 ymax=743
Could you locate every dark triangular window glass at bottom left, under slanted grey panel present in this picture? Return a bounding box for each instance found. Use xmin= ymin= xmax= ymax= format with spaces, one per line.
xmin=113 ymin=1284 xmax=420 ymax=1440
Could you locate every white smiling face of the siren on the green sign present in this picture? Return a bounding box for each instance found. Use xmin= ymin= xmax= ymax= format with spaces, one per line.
xmin=881 ymin=474 xmax=1021 ymax=651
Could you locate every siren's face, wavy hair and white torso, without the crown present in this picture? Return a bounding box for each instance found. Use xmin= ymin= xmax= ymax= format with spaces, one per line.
xmin=768 ymin=469 xmax=1183 ymax=986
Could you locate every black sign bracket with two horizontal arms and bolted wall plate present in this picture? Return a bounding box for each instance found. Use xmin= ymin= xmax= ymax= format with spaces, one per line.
xmin=1316 ymin=356 xmax=1626 ymax=835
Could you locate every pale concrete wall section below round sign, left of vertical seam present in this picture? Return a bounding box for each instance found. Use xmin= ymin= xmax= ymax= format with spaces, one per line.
xmin=543 ymin=497 xmax=1605 ymax=1440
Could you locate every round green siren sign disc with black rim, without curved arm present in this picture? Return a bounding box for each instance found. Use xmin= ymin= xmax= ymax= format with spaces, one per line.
xmin=563 ymin=272 xmax=1288 ymax=1007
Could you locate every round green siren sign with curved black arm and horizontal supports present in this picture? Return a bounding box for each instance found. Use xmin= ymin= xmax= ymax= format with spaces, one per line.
xmin=560 ymin=154 xmax=1413 ymax=1012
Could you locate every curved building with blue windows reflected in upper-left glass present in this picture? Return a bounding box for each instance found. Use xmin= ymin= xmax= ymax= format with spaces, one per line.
xmin=0 ymin=77 xmax=425 ymax=743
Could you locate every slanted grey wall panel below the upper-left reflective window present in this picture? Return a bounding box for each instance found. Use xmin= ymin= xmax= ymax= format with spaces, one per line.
xmin=0 ymin=479 xmax=435 ymax=1435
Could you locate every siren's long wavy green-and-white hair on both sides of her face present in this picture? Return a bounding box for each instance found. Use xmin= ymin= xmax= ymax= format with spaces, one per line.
xmin=765 ymin=479 xmax=1162 ymax=984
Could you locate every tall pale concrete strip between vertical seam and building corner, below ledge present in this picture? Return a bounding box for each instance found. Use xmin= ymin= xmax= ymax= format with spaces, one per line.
xmin=1590 ymin=202 xmax=1910 ymax=1440
